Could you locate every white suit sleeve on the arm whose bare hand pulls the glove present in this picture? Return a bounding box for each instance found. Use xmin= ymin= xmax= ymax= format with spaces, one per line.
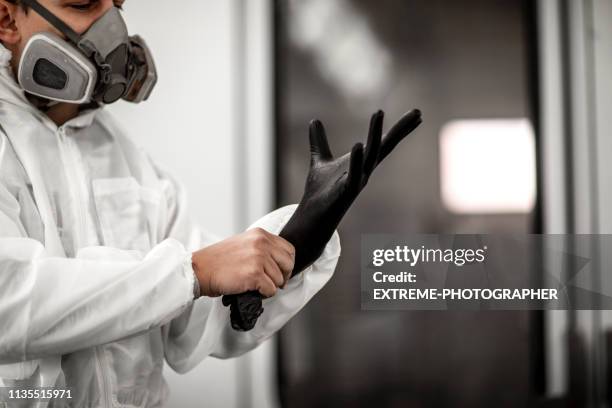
xmin=0 ymin=183 xmax=194 ymax=365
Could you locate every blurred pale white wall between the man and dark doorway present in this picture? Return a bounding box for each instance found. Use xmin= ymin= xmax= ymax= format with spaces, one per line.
xmin=110 ymin=0 xmax=276 ymax=408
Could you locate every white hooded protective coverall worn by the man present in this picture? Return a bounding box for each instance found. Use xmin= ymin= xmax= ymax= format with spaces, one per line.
xmin=0 ymin=45 xmax=340 ymax=408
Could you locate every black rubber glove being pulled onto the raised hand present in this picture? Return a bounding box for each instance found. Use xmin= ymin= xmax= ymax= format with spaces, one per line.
xmin=223 ymin=110 xmax=422 ymax=331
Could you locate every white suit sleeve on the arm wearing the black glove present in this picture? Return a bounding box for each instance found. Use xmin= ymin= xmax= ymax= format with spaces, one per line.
xmin=154 ymin=163 xmax=340 ymax=373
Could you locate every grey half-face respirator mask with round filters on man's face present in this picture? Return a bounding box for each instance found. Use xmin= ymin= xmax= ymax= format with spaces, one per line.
xmin=17 ymin=0 xmax=157 ymax=104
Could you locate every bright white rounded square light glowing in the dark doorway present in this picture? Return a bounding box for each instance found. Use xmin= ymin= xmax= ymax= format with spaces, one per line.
xmin=440 ymin=119 xmax=536 ymax=214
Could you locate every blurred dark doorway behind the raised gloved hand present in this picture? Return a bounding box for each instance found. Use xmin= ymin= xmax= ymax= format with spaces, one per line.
xmin=275 ymin=0 xmax=539 ymax=408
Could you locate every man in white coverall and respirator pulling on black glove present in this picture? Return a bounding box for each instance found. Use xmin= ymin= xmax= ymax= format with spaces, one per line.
xmin=0 ymin=0 xmax=420 ymax=407
